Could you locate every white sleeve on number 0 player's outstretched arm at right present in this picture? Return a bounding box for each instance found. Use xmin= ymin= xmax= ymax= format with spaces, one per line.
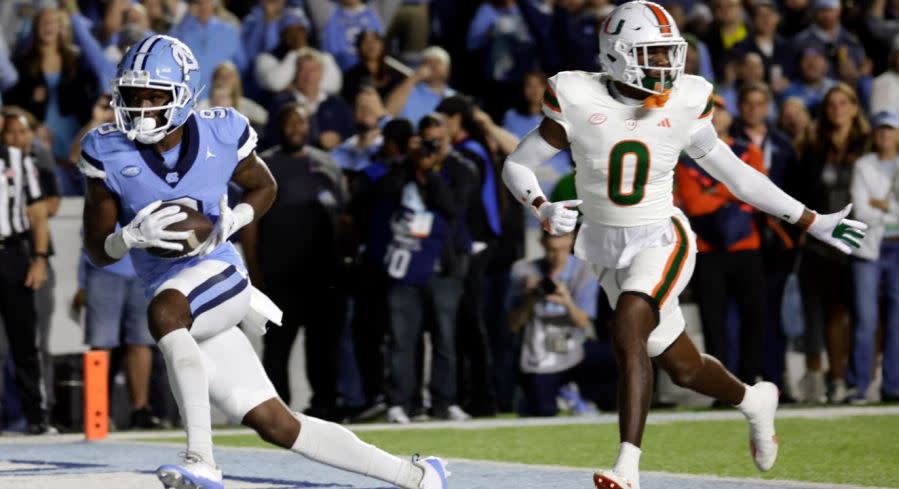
xmin=687 ymin=122 xmax=805 ymax=223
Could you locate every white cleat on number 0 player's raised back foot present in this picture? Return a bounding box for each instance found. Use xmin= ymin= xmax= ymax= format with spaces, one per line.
xmin=743 ymin=382 xmax=780 ymax=472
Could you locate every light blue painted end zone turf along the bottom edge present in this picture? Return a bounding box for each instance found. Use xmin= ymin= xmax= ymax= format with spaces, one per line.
xmin=0 ymin=442 xmax=864 ymax=489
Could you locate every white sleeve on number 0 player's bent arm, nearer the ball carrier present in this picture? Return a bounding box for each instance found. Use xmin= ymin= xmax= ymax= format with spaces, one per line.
xmin=502 ymin=128 xmax=559 ymax=205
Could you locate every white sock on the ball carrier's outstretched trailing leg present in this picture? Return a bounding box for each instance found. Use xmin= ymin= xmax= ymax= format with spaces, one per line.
xmin=291 ymin=413 xmax=424 ymax=489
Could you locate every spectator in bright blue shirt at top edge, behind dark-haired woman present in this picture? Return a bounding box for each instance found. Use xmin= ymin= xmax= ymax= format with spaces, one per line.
xmin=321 ymin=0 xmax=384 ymax=71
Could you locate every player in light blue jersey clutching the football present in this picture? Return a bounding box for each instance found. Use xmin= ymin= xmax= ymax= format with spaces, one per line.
xmin=79 ymin=35 xmax=449 ymax=489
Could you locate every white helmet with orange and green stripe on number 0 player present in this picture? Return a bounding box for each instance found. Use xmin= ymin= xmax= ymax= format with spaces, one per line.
xmin=599 ymin=0 xmax=687 ymax=95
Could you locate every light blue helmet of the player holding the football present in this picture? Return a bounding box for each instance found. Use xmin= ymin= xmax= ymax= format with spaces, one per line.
xmin=112 ymin=34 xmax=203 ymax=144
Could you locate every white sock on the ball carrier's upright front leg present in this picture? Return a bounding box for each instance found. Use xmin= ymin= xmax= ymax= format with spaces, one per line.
xmin=157 ymin=328 xmax=215 ymax=466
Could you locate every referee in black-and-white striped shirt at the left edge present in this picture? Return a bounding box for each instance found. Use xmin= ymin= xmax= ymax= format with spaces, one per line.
xmin=0 ymin=115 xmax=53 ymax=434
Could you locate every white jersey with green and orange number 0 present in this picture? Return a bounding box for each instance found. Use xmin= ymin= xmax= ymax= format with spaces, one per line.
xmin=543 ymin=71 xmax=713 ymax=227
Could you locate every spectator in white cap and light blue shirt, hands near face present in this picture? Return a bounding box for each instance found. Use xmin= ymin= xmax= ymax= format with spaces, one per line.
xmin=387 ymin=46 xmax=456 ymax=125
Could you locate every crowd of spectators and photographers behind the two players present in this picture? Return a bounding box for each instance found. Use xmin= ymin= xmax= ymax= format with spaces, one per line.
xmin=0 ymin=0 xmax=899 ymax=433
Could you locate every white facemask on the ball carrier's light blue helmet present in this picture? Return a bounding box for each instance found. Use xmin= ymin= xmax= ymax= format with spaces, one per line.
xmin=112 ymin=71 xmax=193 ymax=144
